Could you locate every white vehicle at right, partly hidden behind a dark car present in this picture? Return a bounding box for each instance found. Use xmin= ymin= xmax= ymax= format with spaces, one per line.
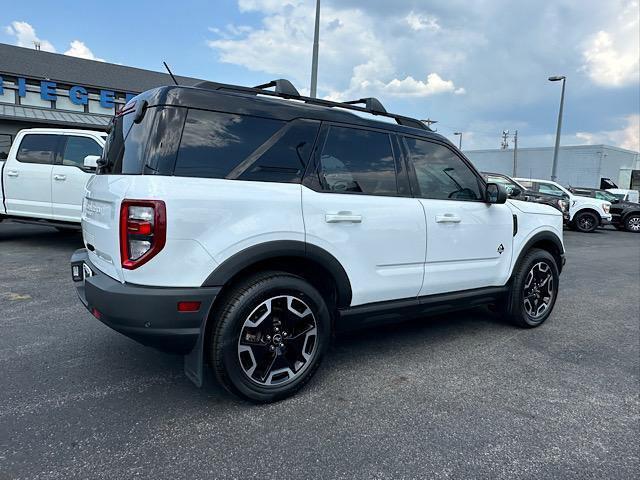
xmin=515 ymin=178 xmax=612 ymax=233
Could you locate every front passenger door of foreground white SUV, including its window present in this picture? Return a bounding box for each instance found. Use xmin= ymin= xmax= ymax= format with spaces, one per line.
xmin=403 ymin=133 xmax=513 ymax=296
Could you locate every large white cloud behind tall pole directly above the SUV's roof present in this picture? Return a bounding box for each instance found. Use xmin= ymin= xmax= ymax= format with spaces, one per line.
xmin=207 ymin=0 xmax=465 ymax=100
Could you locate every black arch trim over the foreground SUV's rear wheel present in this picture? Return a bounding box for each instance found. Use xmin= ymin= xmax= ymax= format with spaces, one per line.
xmin=202 ymin=240 xmax=352 ymax=307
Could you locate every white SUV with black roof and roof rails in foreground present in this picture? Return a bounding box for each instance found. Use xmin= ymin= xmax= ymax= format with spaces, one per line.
xmin=71 ymin=80 xmax=564 ymax=402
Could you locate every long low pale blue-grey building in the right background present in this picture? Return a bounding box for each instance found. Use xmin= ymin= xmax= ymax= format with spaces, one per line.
xmin=464 ymin=145 xmax=640 ymax=190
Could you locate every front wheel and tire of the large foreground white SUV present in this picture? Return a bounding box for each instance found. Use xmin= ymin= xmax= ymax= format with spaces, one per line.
xmin=503 ymin=248 xmax=560 ymax=328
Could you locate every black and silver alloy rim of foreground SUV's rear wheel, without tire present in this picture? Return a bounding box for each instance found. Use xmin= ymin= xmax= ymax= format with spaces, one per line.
xmin=238 ymin=295 xmax=318 ymax=386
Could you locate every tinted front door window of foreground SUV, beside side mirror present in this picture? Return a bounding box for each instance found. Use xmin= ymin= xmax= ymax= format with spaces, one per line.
xmin=406 ymin=138 xmax=482 ymax=200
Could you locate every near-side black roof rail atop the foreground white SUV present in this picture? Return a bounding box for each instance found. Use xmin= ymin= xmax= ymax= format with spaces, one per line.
xmin=194 ymin=78 xmax=431 ymax=131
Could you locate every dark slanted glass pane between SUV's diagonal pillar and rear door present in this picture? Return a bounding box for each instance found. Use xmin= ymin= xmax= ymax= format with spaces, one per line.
xmin=226 ymin=120 xmax=320 ymax=183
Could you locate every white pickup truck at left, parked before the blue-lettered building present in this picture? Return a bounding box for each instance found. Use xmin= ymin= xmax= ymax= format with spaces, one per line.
xmin=0 ymin=128 xmax=107 ymax=229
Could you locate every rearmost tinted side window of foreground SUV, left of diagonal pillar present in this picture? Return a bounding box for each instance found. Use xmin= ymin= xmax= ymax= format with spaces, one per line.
xmin=174 ymin=110 xmax=284 ymax=178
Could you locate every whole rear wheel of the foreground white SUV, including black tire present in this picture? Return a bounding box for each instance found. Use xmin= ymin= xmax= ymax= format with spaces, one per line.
xmin=209 ymin=272 xmax=331 ymax=403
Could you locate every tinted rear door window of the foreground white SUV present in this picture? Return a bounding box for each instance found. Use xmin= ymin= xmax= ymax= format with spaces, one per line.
xmin=320 ymin=126 xmax=398 ymax=195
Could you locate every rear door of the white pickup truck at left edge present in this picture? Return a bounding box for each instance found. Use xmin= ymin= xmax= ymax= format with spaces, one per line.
xmin=3 ymin=133 xmax=61 ymax=219
